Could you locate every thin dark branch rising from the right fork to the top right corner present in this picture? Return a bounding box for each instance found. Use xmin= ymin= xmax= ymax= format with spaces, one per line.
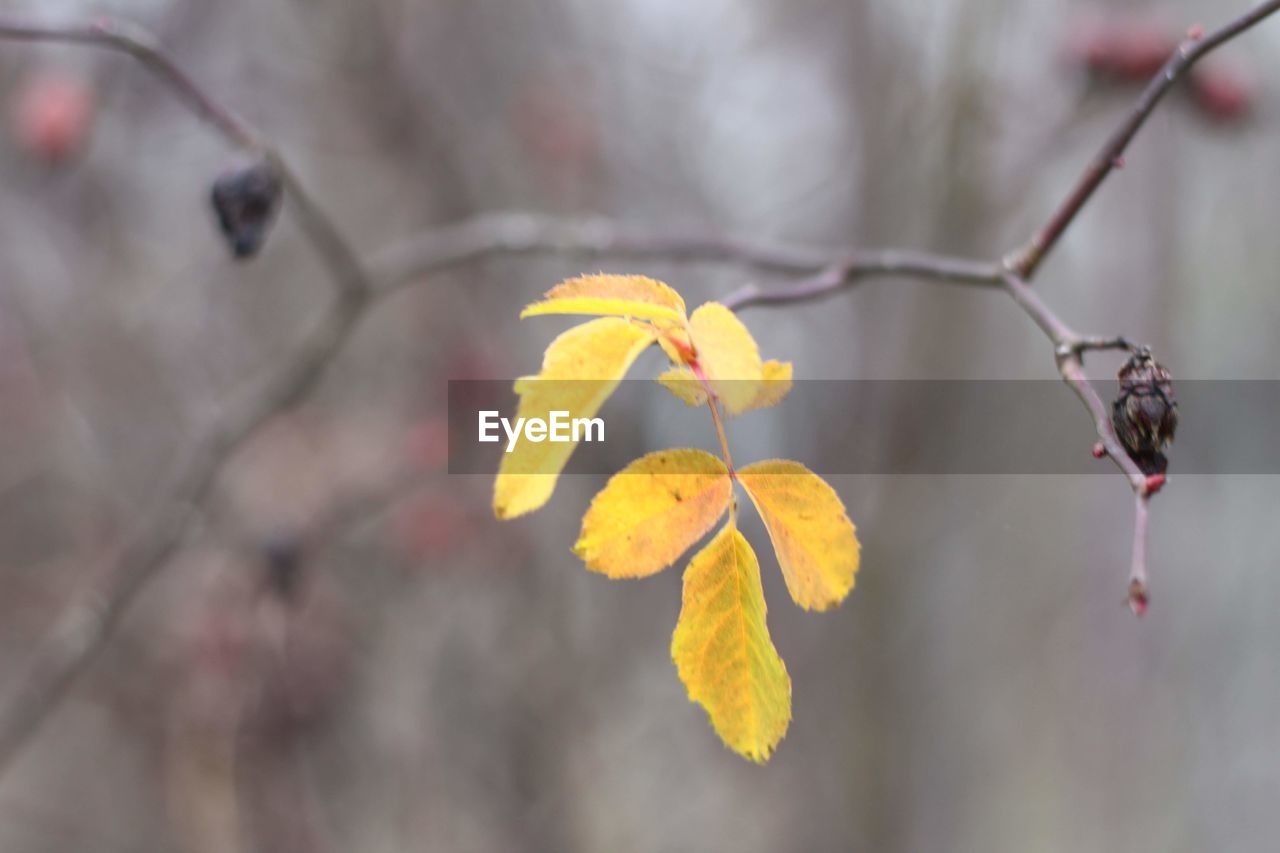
xmin=1007 ymin=0 xmax=1280 ymax=282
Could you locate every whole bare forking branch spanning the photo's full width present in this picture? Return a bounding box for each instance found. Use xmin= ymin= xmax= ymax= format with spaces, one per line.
xmin=0 ymin=0 xmax=1280 ymax=771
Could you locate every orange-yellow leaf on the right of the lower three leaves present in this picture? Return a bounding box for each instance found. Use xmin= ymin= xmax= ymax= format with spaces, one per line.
xmin=737 ymin=460 xmax=859 ymax=610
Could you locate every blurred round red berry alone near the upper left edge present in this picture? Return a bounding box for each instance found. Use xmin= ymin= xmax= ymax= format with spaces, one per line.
xmin=12 ymin=73 xmax=93 ymax=165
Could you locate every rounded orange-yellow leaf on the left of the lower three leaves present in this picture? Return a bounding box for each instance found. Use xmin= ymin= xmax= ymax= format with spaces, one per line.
xmin=573 ymin=450 xmax=733 ymax=578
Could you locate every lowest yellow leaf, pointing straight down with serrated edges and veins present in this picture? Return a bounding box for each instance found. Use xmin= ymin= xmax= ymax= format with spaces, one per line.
xmin=671 ymin=519 xmax=791 ymax=763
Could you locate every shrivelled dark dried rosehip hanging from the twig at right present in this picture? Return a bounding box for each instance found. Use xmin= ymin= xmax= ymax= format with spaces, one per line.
xmin=1111 ymin=347 xmax=1178 ymax=475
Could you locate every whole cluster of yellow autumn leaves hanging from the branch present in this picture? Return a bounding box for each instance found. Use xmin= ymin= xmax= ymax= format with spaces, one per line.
xmin=493 ymin=274 xmax=859 ymax=762
